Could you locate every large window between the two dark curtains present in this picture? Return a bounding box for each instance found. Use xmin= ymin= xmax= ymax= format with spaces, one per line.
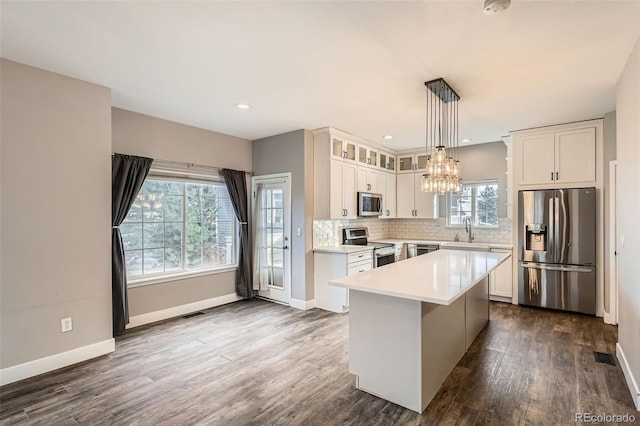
xmin=120 ymin=178 xmax=236 ymax=280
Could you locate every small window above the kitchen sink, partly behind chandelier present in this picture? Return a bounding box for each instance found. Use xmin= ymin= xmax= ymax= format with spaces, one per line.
xmin=447 ymin=181 xmax=498 ymax=227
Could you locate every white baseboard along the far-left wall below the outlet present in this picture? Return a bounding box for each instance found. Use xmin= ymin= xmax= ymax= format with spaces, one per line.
xmin=0 ymin=339 xmax=116 ymax=386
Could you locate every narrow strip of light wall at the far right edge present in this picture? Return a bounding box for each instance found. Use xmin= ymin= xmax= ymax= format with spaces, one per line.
xmin=616 ymin=35 xmax=640 ymax=402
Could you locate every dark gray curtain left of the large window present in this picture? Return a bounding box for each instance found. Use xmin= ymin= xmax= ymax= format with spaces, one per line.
xmin=111 ymin=154 xmax=153 ymax=335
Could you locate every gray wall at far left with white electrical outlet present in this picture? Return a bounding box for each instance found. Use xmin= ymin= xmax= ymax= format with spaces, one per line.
xmin=0 ymin=60 xmax=112 ymax=369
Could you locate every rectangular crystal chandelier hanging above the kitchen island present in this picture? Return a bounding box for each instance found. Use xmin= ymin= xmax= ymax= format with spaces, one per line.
xmin=422 ymin=78 xmax=462 ymax=195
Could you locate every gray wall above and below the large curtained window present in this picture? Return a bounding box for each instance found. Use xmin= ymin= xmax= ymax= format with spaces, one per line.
xmin=112 ymin=108 xmax=251 ymax=316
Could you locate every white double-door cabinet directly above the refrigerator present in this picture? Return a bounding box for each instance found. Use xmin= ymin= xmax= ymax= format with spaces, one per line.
xmin=520 ymin=127 xmax=596 ymax=185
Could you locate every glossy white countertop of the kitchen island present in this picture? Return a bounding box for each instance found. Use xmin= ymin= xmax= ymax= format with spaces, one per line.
xmin=329 ymin=250 xmax=511 ymax=305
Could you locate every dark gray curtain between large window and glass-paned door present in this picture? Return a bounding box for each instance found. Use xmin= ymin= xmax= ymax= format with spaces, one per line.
xmin=220 ymin=169 xmax=254 ymax=298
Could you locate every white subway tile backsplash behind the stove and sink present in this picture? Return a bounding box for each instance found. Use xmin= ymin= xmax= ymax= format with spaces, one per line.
xmin=313 ymin=218 xmax=513 ymax=247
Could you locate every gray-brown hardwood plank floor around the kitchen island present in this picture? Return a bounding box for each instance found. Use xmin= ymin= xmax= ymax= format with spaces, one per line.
xmin=0 ymin=300 xmax=640 ymax=425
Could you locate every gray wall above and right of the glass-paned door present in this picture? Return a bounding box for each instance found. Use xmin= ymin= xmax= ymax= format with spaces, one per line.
xmin=253 ymin=130 xmax=313 ymax=300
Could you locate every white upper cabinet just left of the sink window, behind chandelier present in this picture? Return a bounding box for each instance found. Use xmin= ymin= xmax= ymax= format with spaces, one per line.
xmin=396 ymin=173 xmax=439 ymax=219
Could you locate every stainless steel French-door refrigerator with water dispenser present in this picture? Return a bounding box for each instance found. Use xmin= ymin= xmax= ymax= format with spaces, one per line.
xmin=518 ymin=188 xmax=596 ymax=314
